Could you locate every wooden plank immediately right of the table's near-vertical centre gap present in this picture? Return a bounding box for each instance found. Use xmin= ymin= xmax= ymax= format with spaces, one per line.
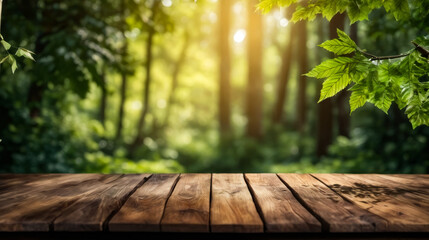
xmin=210 ymin=174 xmax=264 ymax=232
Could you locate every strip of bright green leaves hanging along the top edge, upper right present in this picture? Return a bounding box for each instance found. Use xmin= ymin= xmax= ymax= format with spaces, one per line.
xmin=257 ymin=0 xmax=412 ymax=23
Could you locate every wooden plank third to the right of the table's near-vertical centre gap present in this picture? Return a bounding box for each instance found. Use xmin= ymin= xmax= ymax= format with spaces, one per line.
xmin=278 ymin=174 xmax=387 ymax=232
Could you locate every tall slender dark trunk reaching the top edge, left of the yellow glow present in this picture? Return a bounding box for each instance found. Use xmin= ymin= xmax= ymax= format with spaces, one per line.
xmin=129 ymin=1 xmax=161 ymax=156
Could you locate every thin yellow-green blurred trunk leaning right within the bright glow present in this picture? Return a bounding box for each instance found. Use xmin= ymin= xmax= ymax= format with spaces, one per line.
xmin=161 ymin=30 xmax=189 ymax=128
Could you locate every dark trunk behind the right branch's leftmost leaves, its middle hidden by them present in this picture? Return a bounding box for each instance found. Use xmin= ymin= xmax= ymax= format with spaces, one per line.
xmin=316 ymin=14 xmax=345 ymax=157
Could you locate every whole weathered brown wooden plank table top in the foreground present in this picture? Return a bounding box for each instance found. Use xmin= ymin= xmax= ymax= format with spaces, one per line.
xmin=0 ymin=174 xmax=429 ymax=233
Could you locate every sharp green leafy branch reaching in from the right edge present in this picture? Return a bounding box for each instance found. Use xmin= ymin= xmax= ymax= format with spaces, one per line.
xmin=306 ymin=29 xmax=429 ymax=128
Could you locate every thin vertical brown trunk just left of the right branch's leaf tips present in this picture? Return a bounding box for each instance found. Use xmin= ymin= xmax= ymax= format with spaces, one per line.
xmin=296 ymin=21 xmax=308 ymax=133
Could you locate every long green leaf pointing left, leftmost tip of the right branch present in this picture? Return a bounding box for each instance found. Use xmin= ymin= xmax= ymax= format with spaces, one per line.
xmin=305 ymin=57 xmax=359 ymax=78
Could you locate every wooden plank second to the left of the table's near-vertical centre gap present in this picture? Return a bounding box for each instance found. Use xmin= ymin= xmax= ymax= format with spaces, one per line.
xmin=109 ymin=174 xmax=179 ymax=232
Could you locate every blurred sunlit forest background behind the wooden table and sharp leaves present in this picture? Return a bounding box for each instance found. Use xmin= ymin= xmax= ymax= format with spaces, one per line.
xmin=0 ymin=0 xmax=429 ymax=173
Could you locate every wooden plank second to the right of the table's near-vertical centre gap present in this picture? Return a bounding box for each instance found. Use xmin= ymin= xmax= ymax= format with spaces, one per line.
xmin=245 ymin=174 xmax=322 ymax=232
